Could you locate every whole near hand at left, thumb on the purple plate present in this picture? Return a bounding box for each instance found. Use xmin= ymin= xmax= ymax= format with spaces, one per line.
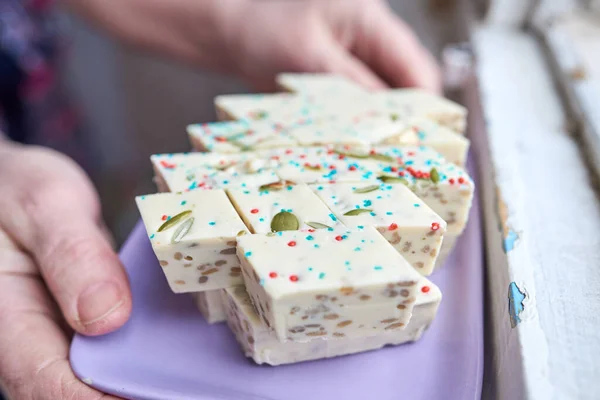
xmin=0 ymin=140 xmax=131 ymax=400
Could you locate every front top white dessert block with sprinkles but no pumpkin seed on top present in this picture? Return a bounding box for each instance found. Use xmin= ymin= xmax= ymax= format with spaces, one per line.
xmin=237 ymin=227 xmax=421 ymax=342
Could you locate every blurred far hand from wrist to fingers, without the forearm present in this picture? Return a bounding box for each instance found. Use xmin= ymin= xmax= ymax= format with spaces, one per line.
xmin=228 ymin=0 xmax=441 ymax=92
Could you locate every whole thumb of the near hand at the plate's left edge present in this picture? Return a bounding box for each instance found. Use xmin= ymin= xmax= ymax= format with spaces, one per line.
xmin=0 ymin=146 xmax=131 ymax=335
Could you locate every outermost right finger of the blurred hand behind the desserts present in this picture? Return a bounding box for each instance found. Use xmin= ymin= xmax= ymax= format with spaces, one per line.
xmin=354 ymin=6 xmax=442 ymax=93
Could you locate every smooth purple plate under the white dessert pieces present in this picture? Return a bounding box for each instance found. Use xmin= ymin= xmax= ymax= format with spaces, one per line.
xmin=71 ymin=188 xmax=483 ymax=400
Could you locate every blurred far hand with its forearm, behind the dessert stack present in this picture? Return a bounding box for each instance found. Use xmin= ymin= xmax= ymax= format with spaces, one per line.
xmin=67 ymin=0 xmax=441 ymax=92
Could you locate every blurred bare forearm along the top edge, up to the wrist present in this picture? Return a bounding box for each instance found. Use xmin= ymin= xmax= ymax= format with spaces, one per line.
xmin=63 ymin=0 xmax=247 ymax=72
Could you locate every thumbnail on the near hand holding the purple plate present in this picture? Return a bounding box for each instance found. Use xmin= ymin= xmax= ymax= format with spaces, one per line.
xmin=77 ymin=282 xmax=123 ymax=326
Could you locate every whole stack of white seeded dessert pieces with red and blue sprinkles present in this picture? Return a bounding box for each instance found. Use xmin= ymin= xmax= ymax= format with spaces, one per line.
xmin=136 ymin=74 xmax=474 ymax=365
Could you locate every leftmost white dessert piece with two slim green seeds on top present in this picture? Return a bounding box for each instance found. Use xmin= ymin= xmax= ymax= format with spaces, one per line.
xmin=136 ymin=190 xmax=247 ymax=293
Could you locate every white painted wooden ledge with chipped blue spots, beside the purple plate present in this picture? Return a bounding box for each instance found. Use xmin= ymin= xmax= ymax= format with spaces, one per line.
xmin=467 ymin=24 xmax=600 ymax=400
